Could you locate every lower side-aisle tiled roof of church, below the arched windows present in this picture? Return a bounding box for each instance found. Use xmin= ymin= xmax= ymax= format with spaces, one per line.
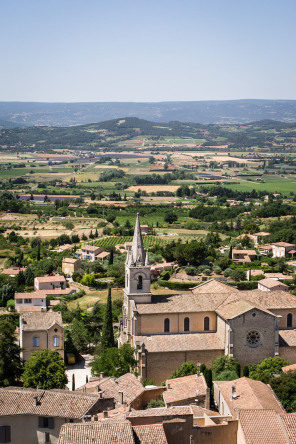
xmin=135 ymin=333 xmax=224 ymax=353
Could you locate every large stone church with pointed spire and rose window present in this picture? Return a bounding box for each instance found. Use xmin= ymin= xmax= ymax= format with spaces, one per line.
xmin=118 ymin=215 xmax=296 ymax=384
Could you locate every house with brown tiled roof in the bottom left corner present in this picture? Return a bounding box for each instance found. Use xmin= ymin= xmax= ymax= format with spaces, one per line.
xmin=0 ymin=387 xmax=114 ymax=444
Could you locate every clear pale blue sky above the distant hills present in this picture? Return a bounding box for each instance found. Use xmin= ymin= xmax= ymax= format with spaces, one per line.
xmin=0 ymin=0 xmax=296 ymax=102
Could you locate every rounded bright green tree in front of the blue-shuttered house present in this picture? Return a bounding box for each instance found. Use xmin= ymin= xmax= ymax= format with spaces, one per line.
xmin=22 ymin=350 xmax=68 ymax=390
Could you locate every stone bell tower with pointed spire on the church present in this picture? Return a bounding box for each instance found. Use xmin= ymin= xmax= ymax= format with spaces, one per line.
xmin=124 ymin=214 xmax=151 ymax=303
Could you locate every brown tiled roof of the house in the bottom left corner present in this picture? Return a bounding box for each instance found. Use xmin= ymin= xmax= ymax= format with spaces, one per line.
xmin=0 ymin=387 xmax=104 ymax=419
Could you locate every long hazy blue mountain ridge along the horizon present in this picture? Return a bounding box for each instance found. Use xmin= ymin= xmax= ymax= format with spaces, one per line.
xmin=0 ymin=100 xmax=296 ymax=128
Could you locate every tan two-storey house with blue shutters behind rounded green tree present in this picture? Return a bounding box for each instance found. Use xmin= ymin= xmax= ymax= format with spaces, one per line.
xmin=20 ymin=312 xmax=64 ymax=361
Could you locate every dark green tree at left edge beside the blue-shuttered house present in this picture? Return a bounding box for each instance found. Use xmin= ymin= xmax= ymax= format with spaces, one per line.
xmin=0 ymin=316 xmax=22 ymax=387
